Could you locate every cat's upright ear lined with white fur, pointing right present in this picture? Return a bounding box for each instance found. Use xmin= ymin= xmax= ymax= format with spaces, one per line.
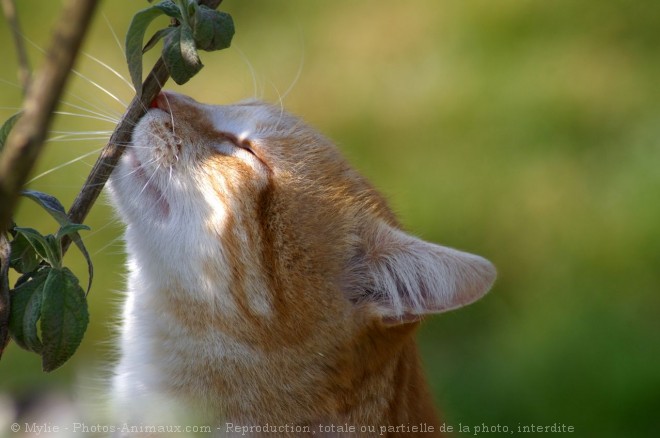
xmin=344 ymin=223 xmax=496 ymax=324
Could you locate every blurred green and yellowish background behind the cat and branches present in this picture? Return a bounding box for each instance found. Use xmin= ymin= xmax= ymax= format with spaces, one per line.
xmin=0 ymin=0 xmax=660 ymax=437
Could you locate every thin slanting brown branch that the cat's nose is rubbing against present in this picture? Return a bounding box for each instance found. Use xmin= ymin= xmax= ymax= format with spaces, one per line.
xmin=62 ymin=58 xmax=169 ymax=252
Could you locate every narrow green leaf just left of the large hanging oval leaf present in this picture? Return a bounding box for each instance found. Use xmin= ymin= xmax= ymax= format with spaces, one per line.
xmin=8 ymin=268 xmax=51 ymax=353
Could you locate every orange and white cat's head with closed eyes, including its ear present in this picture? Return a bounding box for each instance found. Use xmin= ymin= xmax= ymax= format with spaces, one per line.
xmin=112 ymin=92 xmax=495 ymax=342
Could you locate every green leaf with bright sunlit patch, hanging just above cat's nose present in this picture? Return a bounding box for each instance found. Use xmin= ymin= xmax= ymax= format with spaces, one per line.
xmin=163 ymin=23 xmax=203 ymax=85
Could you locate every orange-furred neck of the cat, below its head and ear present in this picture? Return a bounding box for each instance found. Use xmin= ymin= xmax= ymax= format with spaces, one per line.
xmin=129 ymin=268 xmax=438 ymax=436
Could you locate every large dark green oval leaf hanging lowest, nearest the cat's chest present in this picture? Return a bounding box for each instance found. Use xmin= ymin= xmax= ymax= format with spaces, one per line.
xmin=40 ymin=268 xmax=89 ymax=372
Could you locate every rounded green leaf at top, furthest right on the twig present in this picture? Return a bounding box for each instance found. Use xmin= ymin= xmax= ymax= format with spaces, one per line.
xmin=193 ymin=5 xmax=234 ymax=52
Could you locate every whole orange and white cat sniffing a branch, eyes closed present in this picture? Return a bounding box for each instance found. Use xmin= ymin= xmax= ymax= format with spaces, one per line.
xmin=110 ymin=91 xmax=496 ymax=436
